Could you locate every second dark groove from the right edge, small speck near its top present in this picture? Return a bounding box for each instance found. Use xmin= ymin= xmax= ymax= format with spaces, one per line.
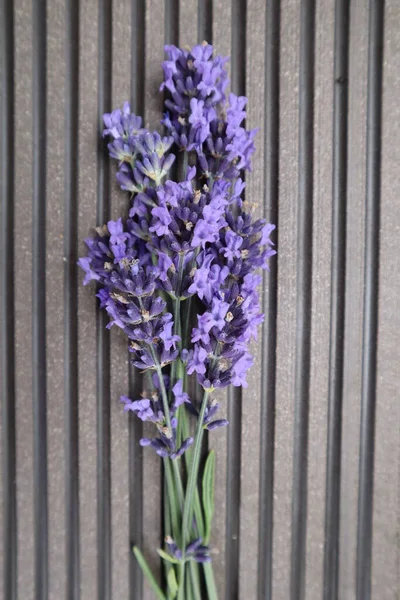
xmin=324 ymin=0 xmax=349 ymax=600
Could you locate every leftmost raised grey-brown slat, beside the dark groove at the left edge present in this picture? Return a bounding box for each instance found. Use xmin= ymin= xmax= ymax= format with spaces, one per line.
xmin=14 ymin=0 xmax=34 ymax=600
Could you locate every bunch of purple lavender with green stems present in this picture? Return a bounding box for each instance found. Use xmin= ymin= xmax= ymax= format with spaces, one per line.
xmin=79 ymin=43 xmax=275 ymax=600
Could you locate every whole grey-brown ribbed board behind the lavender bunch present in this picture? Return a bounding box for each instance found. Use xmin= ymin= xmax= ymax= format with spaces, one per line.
xmin=0 ymin=0 xmax=400 ymax=600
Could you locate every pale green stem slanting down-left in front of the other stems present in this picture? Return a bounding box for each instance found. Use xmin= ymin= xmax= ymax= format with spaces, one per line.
xmin=182 ymin=391 xmax=209 ymax=553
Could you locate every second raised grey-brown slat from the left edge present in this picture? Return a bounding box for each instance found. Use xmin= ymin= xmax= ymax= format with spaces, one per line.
xmin=46 ymin=1 xmax=67 ymax=600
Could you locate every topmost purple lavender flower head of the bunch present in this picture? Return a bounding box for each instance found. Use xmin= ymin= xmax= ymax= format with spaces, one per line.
xmin=161 ymin=43 xmax=256 ymax=180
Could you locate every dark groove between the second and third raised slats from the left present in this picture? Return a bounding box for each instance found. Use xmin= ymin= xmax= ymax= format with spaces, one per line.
xmin=64 ymin=0 xmax=80 ymax=600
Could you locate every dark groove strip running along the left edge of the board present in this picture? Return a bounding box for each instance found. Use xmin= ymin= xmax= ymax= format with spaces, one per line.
xmin=0 ymin=0 xmax=17 ymax=600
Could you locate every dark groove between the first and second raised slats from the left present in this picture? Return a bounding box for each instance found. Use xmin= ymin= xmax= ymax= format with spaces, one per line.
xmin=32 ymin=0 xmax=48 ymax=600
